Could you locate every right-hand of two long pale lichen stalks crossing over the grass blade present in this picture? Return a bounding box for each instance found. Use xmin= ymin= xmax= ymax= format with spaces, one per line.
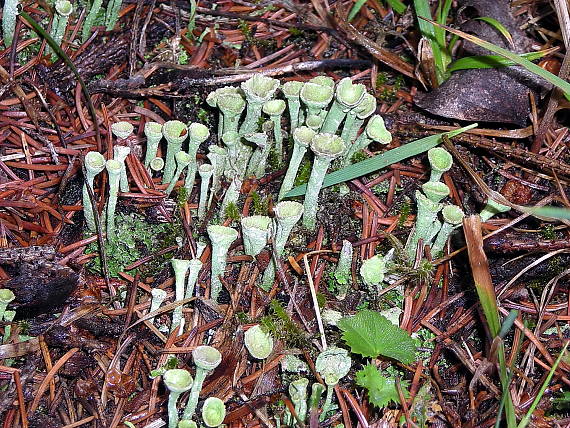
xmin=303 ymin=134 xmax=346 ymax=230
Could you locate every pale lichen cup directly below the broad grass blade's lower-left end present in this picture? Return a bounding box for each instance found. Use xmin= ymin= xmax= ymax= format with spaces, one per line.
xmin=261 ymin=201 xmax=303 ymax=291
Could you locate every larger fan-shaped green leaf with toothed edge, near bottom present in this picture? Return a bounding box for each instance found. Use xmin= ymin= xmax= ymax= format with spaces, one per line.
xmin=338 ymin=310 xmax=416 ymax=364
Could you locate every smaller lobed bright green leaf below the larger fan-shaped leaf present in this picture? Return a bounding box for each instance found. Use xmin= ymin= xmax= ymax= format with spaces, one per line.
xmin=356 ymin=363 xmax=409 ymax=408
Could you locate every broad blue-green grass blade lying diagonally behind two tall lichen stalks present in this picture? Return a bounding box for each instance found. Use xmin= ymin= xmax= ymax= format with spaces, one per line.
xmin=285 ymin=123 xmax=477 ymax=198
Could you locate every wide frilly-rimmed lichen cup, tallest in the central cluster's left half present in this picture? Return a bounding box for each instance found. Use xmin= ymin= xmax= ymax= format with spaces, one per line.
xmin=239 ymin=74 xmax=280 ymax=135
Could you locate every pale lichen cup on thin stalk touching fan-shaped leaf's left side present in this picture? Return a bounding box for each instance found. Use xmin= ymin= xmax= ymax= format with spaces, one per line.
xmin=315 ymin=346 xmax=352 ymax=422
